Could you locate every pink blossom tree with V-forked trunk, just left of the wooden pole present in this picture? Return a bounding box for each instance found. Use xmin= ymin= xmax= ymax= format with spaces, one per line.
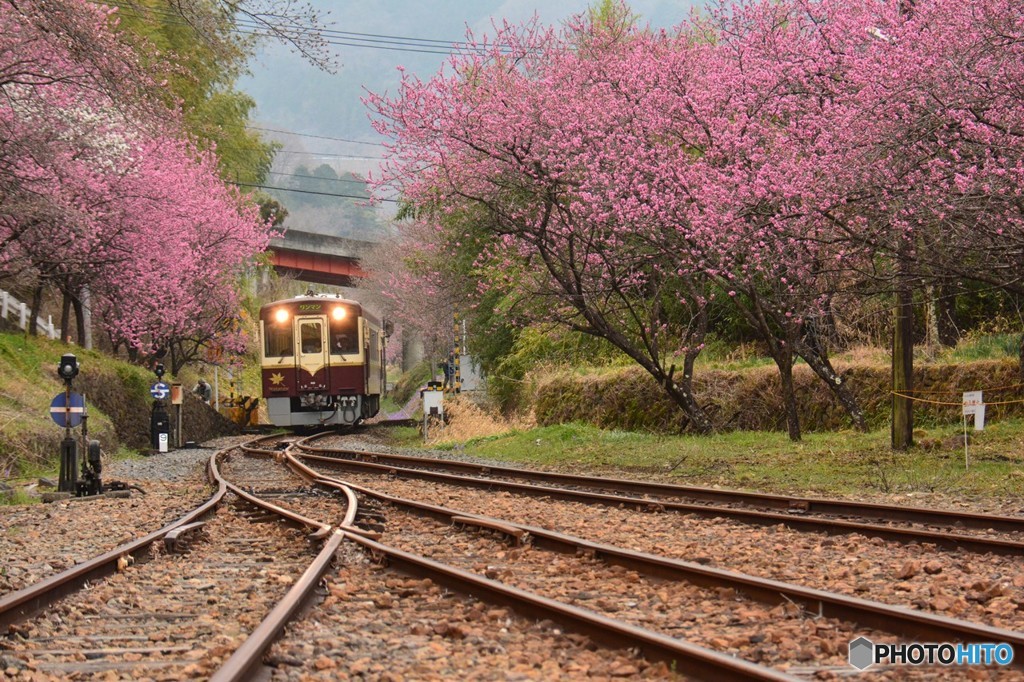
xmin=644 ymin=2 xmax=888 ymax=439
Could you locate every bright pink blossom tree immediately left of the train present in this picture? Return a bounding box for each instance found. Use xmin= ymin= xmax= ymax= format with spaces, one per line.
xmin=88 ymin=139 xmax=269 ymax=364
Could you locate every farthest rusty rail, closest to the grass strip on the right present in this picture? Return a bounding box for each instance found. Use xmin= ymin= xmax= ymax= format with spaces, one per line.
xmin=295 ymin=432 xmax=1024 ymax=532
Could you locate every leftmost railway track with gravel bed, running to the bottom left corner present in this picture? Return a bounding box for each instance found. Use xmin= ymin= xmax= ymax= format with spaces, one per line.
xmin=0 ymin=438 xmax=354 ymax=680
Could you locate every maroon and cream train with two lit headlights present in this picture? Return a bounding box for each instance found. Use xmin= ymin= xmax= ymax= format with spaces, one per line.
xmin=259 ymin=293 xmax=387 ymax=427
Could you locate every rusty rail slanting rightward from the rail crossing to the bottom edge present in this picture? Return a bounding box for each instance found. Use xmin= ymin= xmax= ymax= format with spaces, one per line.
xmin=343 ymin=531 xmax=799 ymax=682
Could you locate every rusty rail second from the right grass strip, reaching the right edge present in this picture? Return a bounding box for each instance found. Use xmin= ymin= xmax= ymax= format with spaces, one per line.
xmin=294 ymin=448 xmax=1024 ymax=556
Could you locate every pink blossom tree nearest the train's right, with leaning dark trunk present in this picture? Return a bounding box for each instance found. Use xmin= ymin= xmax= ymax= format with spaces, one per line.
xmin=370 ymin=13 xmax=712 ymax=432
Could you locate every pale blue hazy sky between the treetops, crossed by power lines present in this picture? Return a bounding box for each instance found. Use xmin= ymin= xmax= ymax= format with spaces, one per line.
xmin=241 ymin=0 xmax=705 ymax=161
